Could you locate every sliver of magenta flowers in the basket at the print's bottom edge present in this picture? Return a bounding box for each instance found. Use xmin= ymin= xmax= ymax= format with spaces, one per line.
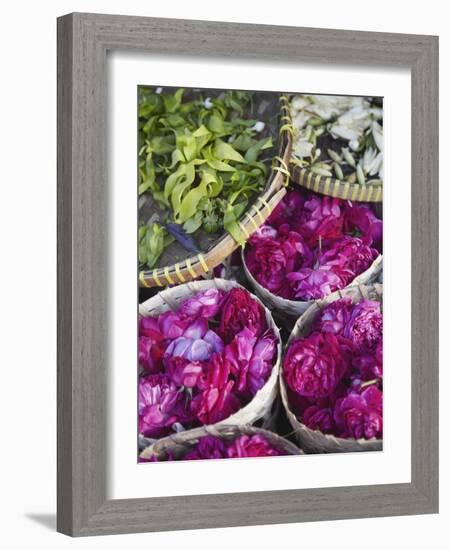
xmin=143 ymin=434 xmax=286 ymax=462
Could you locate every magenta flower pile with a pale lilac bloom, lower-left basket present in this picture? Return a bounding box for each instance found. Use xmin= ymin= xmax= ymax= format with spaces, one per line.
xmin=139 ymin=288 xmax=278 ymax=439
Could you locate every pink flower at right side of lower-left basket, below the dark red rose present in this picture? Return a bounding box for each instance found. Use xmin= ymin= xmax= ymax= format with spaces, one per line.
xmin=225 ymin=328 xmax=277 ymax=397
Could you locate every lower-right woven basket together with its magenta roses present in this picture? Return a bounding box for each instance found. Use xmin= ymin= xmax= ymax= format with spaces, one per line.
xmin=280 ymin=284 xmax=383 ymax=453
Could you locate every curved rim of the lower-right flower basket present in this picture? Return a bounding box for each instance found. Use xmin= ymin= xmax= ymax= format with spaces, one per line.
xmin=279 ymin=283 xmax=383 ymax=452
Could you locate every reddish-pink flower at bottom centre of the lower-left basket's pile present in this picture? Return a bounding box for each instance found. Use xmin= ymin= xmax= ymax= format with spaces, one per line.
xmin=191 ymin=354 xmax=241 ymax=424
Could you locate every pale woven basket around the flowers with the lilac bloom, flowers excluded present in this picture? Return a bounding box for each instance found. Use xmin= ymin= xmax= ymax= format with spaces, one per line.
xmin=139 ymin=279 xmax=281 ymax=436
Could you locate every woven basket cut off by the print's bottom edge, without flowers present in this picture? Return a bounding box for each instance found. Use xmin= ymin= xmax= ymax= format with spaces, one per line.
xmin=140 ymin=425 xmax=304 ymax=460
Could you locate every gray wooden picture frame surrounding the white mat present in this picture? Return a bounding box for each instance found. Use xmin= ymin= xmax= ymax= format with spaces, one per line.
xmin=57 ymin=13 xmax=438 ymax=536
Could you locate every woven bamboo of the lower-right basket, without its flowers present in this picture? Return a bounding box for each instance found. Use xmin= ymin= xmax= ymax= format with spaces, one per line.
xmin=280 ymin=283 xmax=383 ymax=453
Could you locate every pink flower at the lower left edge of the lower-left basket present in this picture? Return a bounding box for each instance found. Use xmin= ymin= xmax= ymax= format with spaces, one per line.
xmin=139 ymin=374 xmax=181 ymax=438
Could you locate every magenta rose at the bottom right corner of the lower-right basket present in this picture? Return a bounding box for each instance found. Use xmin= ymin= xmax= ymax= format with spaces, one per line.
xmin=334 ymin=385 xmax=383 ymax=439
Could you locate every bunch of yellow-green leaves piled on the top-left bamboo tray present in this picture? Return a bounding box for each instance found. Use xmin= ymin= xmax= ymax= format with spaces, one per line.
xmin=139 ymin=87 xmax=272 ymax=268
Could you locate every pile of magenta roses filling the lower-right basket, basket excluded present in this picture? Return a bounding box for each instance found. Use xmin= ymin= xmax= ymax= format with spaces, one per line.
xmin=283 ymin=298 xmax=383 ymax=439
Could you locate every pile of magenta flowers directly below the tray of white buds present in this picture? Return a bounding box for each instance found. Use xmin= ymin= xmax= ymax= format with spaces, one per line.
xmin=245 ymin=190 xmax=382 ymax=301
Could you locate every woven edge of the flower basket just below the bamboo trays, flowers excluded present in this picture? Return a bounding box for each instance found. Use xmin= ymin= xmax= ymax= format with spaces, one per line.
xmin=242 ymin=248 xmax=383 ymax=321
